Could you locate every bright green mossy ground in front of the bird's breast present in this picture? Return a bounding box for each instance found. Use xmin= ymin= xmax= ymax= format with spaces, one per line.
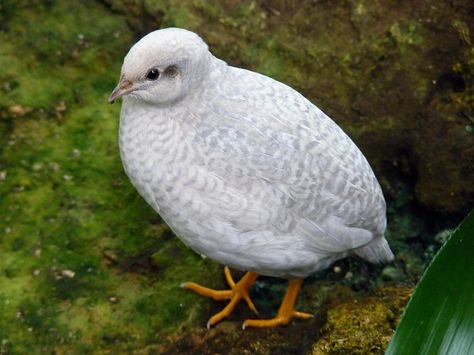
xmin=0 ymin=1 xmax=224 ymax=352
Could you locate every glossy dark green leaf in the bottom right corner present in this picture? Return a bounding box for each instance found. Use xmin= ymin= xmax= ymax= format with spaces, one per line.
xmin=385 ymin=211 xmax=474 ymax=355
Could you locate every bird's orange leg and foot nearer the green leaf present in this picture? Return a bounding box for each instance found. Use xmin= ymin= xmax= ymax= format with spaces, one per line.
xmin=242 ymin=279 xmax=313 ymax=329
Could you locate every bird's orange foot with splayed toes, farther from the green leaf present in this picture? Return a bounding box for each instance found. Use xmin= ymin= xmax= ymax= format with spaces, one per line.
xmin=181 ymin=266 xmax=258 ymax=328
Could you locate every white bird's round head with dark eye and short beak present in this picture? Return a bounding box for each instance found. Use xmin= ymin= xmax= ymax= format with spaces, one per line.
xmin=109 ymin=28 xmax=212 ymax=106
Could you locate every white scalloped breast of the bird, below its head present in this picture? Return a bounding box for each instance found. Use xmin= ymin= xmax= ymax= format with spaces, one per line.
xmin=119 ymin=101 xmax=231 ymax=239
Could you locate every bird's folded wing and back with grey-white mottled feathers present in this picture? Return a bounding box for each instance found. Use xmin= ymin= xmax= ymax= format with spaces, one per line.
xmin=181 ymin=68 xmax=384 ymax=251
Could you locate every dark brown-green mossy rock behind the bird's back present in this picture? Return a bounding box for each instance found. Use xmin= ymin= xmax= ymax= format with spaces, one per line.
xmin=105 ymin=0 xmax=474 ymax=214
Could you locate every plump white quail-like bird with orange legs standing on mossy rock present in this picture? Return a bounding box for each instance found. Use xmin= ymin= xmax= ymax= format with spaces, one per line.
xmin=109 ymin=28 xmax=394 ymax=328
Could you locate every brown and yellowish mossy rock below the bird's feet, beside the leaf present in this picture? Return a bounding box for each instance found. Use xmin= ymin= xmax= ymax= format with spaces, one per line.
xmin=155 ymin=285 xmax=412 ymax=355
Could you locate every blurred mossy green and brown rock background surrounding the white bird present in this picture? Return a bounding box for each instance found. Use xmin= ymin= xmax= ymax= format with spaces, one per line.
xmin=0 ymin=0 xmax=474 ymax=354
